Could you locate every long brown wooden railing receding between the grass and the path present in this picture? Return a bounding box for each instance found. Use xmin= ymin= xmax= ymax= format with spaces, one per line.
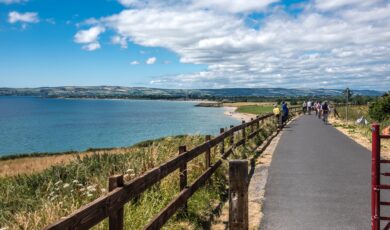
xmin=45 ymin=107 xmax=301 ymax=230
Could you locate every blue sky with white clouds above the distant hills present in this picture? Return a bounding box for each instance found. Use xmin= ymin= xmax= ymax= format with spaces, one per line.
xmin=0 ymin=0 xmax=390 ymax=90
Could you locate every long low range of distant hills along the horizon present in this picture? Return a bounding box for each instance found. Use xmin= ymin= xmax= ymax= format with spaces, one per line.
xmin=0 ymin=86 xmax=383 ymax=98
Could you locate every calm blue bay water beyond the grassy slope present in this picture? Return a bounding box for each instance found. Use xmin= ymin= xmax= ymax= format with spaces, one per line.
xmin=0 ymin=97 xmax=238 ymax=156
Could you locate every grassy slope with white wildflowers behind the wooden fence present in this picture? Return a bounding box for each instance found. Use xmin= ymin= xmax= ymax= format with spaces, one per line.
xmin=0 ymin=117 xmax=275 ymax=229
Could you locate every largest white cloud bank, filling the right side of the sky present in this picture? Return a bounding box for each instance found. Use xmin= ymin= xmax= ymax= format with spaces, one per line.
xmin=74 ymin=0 xmax=390 ymax=90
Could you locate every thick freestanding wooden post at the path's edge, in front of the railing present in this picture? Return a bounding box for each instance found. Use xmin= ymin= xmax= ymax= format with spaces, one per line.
xmin=229 ymin=160 xmax=249 ymax=230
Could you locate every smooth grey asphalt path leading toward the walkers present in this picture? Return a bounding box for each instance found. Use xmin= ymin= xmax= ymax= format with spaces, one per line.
xmin=260 ymin=115 xmax=371 ymax=230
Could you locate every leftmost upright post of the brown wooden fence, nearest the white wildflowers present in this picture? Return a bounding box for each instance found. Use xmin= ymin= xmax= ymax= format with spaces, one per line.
xmin=108 ymin=175 xmax=123 ymax=230
